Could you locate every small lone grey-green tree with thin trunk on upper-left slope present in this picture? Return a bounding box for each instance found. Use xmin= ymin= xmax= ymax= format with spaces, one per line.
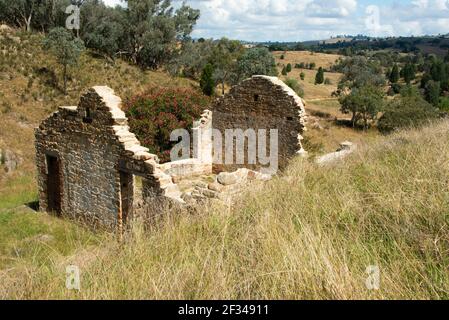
xmin=43 ymin=28 xmax=84 ymax=93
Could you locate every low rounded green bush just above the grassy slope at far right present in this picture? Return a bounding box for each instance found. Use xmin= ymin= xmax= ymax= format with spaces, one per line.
xmin=377 ymin=94 xmax=438 ymax=133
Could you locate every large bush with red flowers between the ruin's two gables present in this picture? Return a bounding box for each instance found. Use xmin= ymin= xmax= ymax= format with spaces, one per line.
xmin=124 ymin=87 xmax=210 ymax=162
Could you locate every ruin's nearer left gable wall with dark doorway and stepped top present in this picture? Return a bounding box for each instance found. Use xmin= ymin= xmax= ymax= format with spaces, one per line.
xmin=35 ymin=87 xmax=182 ymax=226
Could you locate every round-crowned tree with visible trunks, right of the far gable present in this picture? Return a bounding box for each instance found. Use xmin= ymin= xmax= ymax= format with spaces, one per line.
xmin=340 ymin=85 xmax=384 ymax=130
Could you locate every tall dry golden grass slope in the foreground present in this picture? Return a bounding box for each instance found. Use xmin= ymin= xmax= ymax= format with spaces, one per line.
xmin=0 ymin=121 xmax=449 ymax=299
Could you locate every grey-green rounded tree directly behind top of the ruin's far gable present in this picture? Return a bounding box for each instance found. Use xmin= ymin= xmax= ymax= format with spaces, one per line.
xmin=237 ymin=48 xmax=278 ymax=82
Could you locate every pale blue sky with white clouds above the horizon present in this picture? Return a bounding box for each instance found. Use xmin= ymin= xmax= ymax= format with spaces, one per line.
xmin=104 ymin=0 xmax=449 ymax=41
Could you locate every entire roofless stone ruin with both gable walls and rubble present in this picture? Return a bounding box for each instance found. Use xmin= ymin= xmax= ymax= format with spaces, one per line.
xmin=35 ymin=76 xmax=305 ymax=227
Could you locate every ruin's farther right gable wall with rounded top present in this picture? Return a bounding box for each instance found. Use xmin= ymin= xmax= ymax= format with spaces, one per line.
xmin=212 ymin=76 xmax=306 ymax=171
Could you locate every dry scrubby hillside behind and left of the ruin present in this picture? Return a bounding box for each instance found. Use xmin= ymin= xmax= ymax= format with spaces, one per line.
xmin=0 ymin=31 xmax=195 ymax=211
